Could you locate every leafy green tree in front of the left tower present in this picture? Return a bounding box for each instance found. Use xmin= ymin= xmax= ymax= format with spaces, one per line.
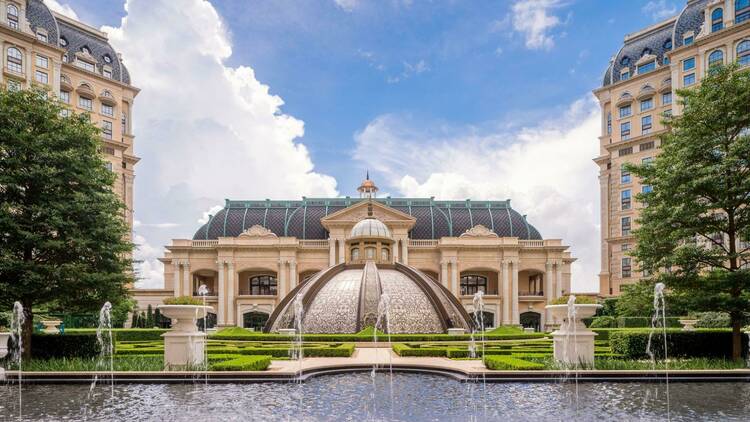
xmin=0 ymin=88 xmax=132 ymax=357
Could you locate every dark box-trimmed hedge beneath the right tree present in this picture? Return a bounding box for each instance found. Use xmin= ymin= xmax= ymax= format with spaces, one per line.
xmin=609 ymin=329 xmax=748 ymax=359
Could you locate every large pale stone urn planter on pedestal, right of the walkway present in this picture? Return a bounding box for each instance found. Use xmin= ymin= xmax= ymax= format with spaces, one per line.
xmin=546 ymin=304 xmax=602 ymax=367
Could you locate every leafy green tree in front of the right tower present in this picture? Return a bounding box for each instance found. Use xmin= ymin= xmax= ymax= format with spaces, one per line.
xmin=629 ymin=65 xmax=750 ymax=359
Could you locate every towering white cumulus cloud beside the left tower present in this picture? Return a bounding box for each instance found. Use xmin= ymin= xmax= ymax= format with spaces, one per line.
xmin=95 ymin=0 xmax=338 ymax=287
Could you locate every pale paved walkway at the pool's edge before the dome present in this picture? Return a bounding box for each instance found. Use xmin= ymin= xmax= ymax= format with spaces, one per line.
xmin=268 ymin=347 xmax=485 ymax=375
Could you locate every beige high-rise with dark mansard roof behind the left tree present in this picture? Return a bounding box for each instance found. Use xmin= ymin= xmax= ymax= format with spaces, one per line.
xmin=0 ymin=0 xmax=139 ymax=232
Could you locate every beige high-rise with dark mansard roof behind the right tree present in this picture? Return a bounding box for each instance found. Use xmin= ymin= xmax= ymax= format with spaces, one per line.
xmin=594 ymin=0 xmax=750 ymax=296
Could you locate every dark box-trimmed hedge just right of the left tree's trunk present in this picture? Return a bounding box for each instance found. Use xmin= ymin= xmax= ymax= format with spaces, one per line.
xmin=31 ymin=331 xmax=110 ymax=359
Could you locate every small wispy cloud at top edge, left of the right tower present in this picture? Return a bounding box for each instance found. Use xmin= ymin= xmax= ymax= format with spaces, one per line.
xmin=511 ymin=0 xmax=564 ymax=50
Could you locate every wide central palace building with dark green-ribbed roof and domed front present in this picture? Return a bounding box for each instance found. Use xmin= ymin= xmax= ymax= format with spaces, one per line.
xmin=133 ymin=178 xmax=575 ymax=332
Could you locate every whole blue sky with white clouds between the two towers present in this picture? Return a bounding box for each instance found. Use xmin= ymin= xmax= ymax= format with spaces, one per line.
xmin=45 ymin=0 xmax=684 ymax=291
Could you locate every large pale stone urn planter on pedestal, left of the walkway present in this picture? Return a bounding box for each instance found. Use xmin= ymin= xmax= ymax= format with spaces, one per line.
xmin=156 ymin=305 xmax=213 ymax=368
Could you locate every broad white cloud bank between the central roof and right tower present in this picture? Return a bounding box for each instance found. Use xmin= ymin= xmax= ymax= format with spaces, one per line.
xmin=354 ymin=98 xmax=600 ymax=291
